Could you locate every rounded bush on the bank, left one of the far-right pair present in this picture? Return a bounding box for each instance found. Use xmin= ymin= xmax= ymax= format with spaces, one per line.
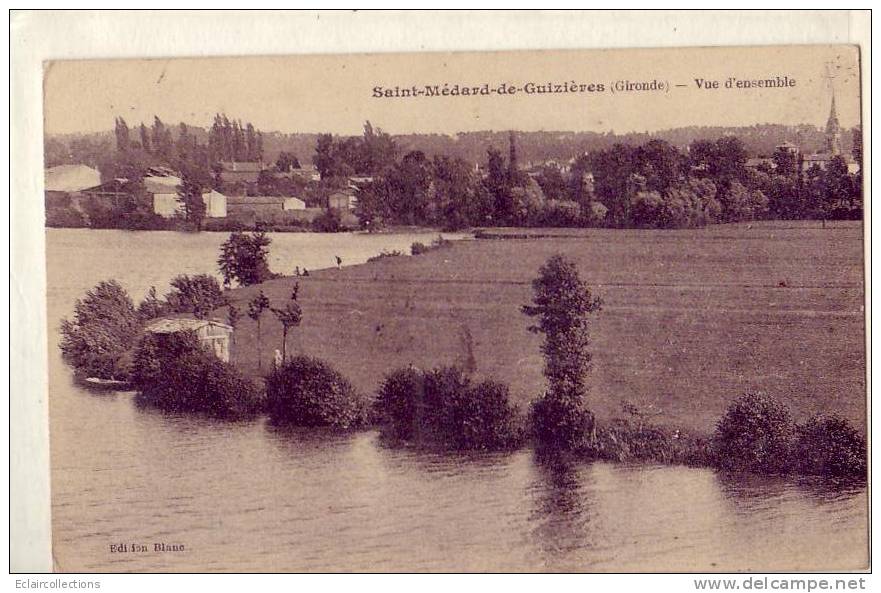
xmin=713 ymin=393 xmax=794 ymax=473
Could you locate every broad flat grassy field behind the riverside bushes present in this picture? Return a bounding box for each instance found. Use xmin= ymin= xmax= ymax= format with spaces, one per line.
xmin=217 ymin=222 xmax=866 ymax=431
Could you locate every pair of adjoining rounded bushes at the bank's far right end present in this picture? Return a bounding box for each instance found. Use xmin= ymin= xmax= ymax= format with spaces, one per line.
xmin=712 ymin=393 xmax=866 ymax=477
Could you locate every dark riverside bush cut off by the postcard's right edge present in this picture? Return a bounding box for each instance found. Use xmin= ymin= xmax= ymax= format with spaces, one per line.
xmin=793 ymin=415 xmax=866 ymax=477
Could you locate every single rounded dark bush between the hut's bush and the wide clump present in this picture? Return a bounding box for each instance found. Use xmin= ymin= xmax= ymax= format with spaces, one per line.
xmin=266 ymin=356 xmax=368 ymax=429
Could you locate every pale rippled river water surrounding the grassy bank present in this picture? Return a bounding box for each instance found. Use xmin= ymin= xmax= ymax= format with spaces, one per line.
xmin=47 ymin=229 xmax=868 ymax=572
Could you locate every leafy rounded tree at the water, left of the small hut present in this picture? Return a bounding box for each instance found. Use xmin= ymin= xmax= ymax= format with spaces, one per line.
xmin=61 ymin=280 xmax=141 ymax=379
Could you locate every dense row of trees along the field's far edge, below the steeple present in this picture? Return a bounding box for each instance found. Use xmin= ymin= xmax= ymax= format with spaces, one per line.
xmin=346 ymin=133 xmax=862 ymax=229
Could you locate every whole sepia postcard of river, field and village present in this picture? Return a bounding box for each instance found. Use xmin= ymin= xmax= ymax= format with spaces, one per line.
xmin=10 ymin=11 xmax=870 ymax=573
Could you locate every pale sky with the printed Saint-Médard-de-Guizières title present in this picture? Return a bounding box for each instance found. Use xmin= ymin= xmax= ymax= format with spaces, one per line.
xmin=44 ymin=45 xmax=860 ymax=134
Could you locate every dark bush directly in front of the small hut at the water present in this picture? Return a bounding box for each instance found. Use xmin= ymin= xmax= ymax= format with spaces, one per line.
xmin=132 ymin=332 xmax=262 ymax=420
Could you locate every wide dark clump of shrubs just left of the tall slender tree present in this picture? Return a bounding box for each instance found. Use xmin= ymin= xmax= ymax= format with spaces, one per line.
xmin=376 ymin=367 xmax=524 ymax=450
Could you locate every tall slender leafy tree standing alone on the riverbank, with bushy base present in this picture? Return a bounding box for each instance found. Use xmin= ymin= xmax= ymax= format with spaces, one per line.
xmin=522 ymin=255 xmax=602 ymax=449
